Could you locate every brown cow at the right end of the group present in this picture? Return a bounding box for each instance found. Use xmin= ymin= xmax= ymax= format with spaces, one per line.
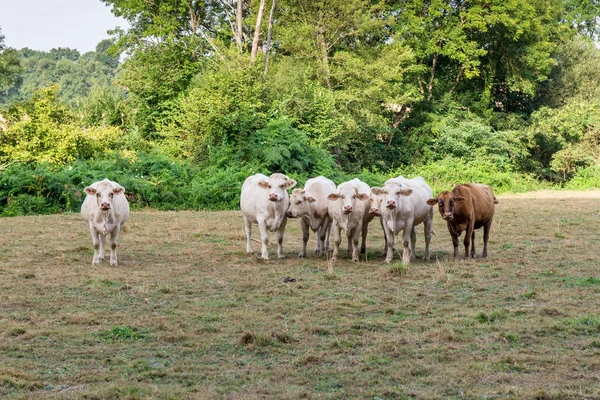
xmin=427 ymin=183 xmax=498 ymax=258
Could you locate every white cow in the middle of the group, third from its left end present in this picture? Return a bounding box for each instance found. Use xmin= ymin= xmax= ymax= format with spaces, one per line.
xmin=327 ymin=178 xmax=374 ymax=262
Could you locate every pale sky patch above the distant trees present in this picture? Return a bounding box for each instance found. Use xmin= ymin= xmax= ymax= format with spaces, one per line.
xmin=0 ymin=0 xmax=128 ymax=54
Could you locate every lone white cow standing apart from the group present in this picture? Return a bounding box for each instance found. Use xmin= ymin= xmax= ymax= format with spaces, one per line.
xmin=81 ymin=179 xmax=129 ymax=266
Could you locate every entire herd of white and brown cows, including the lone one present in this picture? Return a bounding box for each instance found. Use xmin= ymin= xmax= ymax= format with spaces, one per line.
xmin=81 ymin=173 xmax=498 ymax=266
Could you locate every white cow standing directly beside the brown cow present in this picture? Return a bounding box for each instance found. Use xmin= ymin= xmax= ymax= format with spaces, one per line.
xmin=371 ymin=176 xmax=433 ymax=264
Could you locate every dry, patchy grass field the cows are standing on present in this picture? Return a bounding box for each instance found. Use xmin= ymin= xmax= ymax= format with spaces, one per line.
xmin=0 ymin=192 xmax=600 ymax=399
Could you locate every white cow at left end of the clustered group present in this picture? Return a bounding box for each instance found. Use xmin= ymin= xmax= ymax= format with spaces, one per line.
xmin=240 ymin=174 xmax=296 ymax=260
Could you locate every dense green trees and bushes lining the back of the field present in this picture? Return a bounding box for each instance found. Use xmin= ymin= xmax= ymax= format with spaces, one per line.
xmin=0 ymin=0 xmax=600 ymax=215
